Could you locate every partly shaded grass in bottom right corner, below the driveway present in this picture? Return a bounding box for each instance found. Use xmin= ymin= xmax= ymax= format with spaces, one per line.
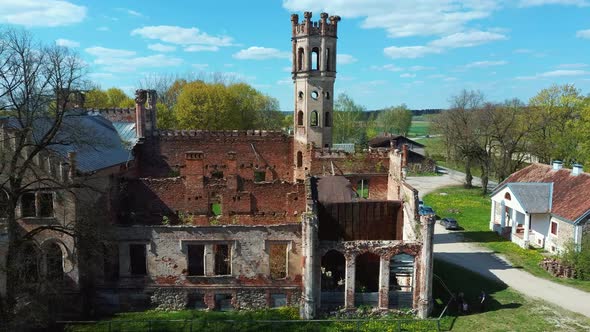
xmin=434 ymin=260 xmax=590 ymax=332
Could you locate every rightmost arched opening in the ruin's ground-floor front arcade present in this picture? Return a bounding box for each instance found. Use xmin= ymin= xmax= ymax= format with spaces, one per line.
xmin=389 ymin=254 xmax=414 ymax=308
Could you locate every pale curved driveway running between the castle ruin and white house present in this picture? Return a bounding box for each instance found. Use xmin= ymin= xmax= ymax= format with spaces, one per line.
xmin=407 ymin=171 xmax=590 ymax=317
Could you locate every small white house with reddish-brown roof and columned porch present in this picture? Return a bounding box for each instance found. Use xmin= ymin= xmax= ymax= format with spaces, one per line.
xmin=490 ymin=161 xmax=590 ymax=253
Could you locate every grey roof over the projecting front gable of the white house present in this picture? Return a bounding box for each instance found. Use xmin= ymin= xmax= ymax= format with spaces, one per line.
xmin=508 ymin=182 xmax=553 ymax=213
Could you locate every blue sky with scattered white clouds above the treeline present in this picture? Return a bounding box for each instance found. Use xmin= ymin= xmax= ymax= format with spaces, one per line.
xmin=0 ymin=0 xmax=590 ymax=111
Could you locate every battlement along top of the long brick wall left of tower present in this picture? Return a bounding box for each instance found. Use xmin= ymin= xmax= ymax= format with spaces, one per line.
xmin=154 ymin=130 xmax=289 ymax=140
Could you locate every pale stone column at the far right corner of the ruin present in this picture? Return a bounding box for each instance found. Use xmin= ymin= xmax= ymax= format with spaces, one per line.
xmin=418 ymin=217 xmax=435 ymax=318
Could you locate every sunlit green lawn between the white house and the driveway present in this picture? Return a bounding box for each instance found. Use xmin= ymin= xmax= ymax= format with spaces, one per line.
xmin=424 ymin=187 xmax=590 ymax=292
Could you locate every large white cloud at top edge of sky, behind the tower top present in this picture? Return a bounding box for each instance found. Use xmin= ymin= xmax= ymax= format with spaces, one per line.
xmin=283 ymin=0 xmax=501 ymax=37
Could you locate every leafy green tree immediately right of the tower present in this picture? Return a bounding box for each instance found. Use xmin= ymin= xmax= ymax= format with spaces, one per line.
xmin=332 ymin=93 xmax=365 ymax=144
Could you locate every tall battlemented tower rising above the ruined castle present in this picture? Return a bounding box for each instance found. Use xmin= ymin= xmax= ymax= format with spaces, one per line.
xmin=291 ymin=12 xmax=340 ymax=180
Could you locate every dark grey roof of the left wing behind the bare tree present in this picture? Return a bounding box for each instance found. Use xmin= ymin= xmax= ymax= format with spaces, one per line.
xmin=3 ymin=113 xmax=133 ymax=173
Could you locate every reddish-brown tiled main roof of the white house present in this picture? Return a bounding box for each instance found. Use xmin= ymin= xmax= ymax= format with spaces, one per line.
xmin=494 ymin=164 xmax=590 ymax=222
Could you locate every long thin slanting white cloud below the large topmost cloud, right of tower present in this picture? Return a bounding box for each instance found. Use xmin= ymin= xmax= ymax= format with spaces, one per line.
xmin=383 ymin=30 xmax=507 ymax=59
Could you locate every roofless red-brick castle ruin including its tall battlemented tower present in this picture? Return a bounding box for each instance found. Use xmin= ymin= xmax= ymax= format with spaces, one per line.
xmin=0 ymin=12 xmax=433 ymax=319
